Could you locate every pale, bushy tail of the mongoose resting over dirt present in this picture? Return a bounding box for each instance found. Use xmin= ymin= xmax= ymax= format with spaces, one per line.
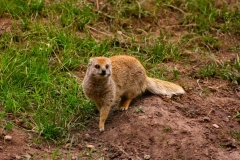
xmin=147 ymin=77 xmax=185 ymax=97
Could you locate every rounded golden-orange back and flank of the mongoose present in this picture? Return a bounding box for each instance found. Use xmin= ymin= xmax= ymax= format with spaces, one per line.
xmin=110 ymin=55 xmax=146 ymax=98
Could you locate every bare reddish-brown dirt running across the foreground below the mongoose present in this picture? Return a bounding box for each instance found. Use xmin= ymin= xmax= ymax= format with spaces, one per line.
xmin=0 ymin=79 xmax=240 ymax=160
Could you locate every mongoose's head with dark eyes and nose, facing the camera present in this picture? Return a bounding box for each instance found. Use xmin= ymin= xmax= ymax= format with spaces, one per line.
xmin=88 ymin=57 xmax=112 ymax=78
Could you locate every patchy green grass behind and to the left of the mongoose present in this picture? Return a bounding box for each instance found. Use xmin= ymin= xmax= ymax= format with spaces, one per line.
xmin=0 ymin=0 xmax=240 ymax=143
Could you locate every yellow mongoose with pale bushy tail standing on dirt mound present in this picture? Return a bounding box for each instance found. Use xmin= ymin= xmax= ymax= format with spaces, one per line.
xmin=82 ymin=55 xmax=185 ymax=131
